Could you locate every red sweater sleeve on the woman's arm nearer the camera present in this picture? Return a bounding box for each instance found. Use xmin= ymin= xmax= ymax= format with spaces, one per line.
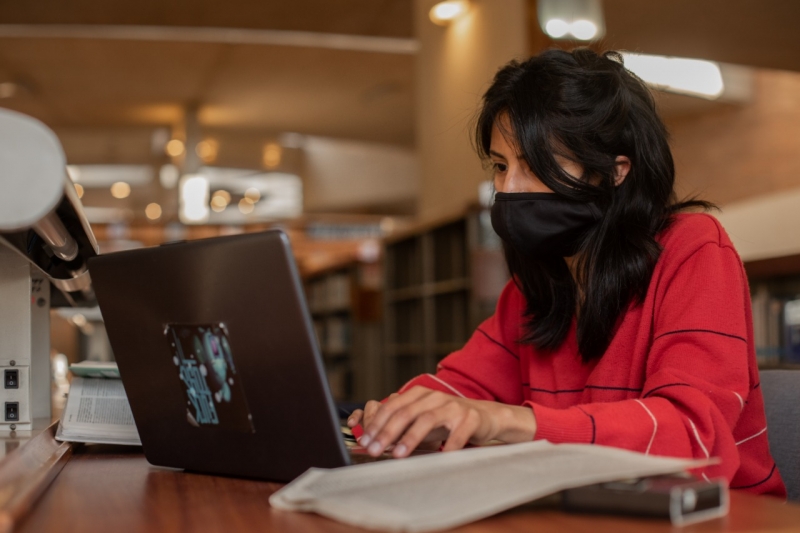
xmin=528 ymin=243 xmax=750 ymax=481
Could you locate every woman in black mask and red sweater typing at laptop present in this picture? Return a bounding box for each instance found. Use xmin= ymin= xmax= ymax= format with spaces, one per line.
xmin=348 ymin=49 xmax=785 ymax=496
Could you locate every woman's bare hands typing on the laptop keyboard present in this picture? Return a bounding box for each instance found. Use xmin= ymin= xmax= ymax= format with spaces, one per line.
xmin=347 ymin=386 xmax=536 ymax=457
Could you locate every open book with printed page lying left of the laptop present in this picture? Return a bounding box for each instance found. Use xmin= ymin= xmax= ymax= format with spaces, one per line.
xmin=56 ymin=376 xmax=142 ymax=446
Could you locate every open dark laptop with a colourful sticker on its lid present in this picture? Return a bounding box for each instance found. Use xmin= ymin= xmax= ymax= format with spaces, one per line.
xmin=89 ymin=230 xmax=363 ymax=482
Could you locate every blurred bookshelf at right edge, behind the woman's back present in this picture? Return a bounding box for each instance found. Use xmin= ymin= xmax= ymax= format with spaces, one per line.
xmin=745 ymin=255 xmax=800 ymax=369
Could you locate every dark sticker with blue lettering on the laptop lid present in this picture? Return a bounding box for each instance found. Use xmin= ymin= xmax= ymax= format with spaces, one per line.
xmin=164 ymin=322 xmax=255 ymax=433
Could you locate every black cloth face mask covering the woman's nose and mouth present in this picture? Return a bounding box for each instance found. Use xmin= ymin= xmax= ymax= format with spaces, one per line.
xmin=492 ymin=192 xmax=603 ymax=259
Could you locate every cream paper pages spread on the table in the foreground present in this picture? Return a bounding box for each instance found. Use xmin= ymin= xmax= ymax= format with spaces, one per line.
xmin=269 ymin=441 xmax=727 ymax=532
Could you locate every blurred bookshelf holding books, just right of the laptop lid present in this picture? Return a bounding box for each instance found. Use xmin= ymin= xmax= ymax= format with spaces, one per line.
xmin=304 ymin=262 xmax=383 ymax=402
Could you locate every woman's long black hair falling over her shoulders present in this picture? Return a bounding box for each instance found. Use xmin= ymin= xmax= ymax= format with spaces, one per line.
xmin=475 ymin=48 xmax=712 ymax=362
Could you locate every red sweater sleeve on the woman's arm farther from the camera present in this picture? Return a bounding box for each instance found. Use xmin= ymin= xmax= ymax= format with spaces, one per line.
xmin=400 ymin=281 xmax=524 ymax=405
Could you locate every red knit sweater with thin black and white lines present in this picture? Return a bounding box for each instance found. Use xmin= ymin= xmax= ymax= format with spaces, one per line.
xmin=401 ymin=214 xmax=786 ymax=497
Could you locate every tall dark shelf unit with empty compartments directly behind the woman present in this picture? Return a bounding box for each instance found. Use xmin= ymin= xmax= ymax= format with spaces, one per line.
xmin=383 ymin=211 xmax=508 ymax=394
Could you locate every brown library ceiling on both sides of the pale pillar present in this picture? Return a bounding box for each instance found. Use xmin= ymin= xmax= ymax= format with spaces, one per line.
xmin=0 ymin=0 xmax=800 ymax=163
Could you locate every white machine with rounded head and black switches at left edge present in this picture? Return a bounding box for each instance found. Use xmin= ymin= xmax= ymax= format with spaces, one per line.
xmin=0 ymin=109 xmax=98 ymax=431
